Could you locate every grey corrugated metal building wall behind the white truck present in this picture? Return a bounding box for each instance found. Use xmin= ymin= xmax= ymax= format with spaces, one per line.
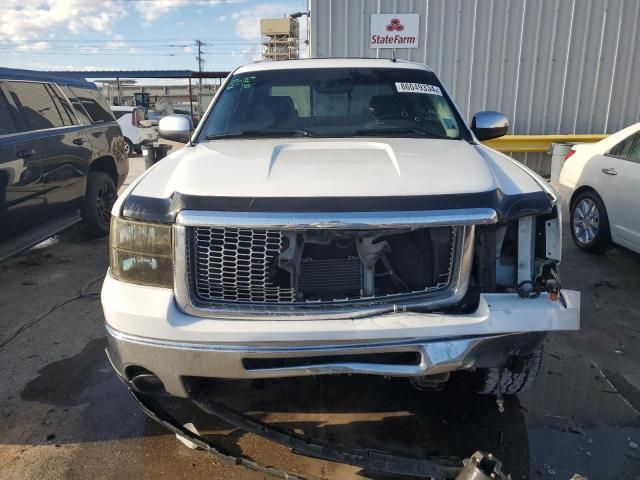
xmin=310 ymin=0 xmax=640 ymax=173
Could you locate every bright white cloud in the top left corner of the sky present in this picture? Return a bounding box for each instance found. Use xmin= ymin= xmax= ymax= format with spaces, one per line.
xmin=0 ymin=0 xmax=126 ymax=43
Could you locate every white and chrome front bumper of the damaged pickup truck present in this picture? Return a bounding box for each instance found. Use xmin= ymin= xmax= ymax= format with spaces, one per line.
xmin=102 ymin=275 xmax=580 ymax=397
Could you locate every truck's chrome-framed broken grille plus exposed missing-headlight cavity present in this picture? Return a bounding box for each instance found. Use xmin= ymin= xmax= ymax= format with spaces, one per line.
xmin=175 ymin=202 xmax=561 ymax=319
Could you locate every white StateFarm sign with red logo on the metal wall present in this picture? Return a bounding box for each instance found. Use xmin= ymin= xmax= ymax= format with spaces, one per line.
xmin=369 ymin=13 xmax=420 ymax=48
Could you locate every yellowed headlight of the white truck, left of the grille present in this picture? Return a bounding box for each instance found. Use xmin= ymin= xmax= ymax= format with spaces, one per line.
xmin=109 ymin=217 xmax=173 ymax=288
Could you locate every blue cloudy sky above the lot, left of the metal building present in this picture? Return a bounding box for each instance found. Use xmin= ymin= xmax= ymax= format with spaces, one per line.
xmin=0 ymin=0 xmax=307 ymax=77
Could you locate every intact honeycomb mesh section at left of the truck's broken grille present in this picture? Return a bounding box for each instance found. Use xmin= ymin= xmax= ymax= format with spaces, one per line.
xmin=190 ymin=227 xmax=295 ymax=303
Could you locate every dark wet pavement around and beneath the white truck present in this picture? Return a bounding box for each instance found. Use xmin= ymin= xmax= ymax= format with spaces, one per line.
xmin=0 ymin=156 xmax=640 ymax=480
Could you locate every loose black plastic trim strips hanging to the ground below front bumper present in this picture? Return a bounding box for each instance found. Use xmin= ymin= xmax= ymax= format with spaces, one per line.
xmin=130 ymin=385 xmax=462 ymax=480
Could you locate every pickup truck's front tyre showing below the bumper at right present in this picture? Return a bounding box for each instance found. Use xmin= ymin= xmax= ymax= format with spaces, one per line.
xmin=476 ymin=347 xmax=542 ymax=395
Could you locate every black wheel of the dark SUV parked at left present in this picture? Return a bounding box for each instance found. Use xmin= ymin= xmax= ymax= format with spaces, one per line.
xmin=82 ymin=172 xmax=118 ymax=237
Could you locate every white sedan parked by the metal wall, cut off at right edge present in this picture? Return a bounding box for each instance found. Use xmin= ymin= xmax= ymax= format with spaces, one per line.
xmin=559 ymin=123 xmax=640 ymax=253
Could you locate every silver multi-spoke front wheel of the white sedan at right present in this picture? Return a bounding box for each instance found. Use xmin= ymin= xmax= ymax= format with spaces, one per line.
xmin=570 ymin=191 xmax=611 ymax=252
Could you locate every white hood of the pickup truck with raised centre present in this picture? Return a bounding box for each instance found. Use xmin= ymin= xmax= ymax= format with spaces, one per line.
xmin=129 ymin=138 xmax=541 ymax=199
